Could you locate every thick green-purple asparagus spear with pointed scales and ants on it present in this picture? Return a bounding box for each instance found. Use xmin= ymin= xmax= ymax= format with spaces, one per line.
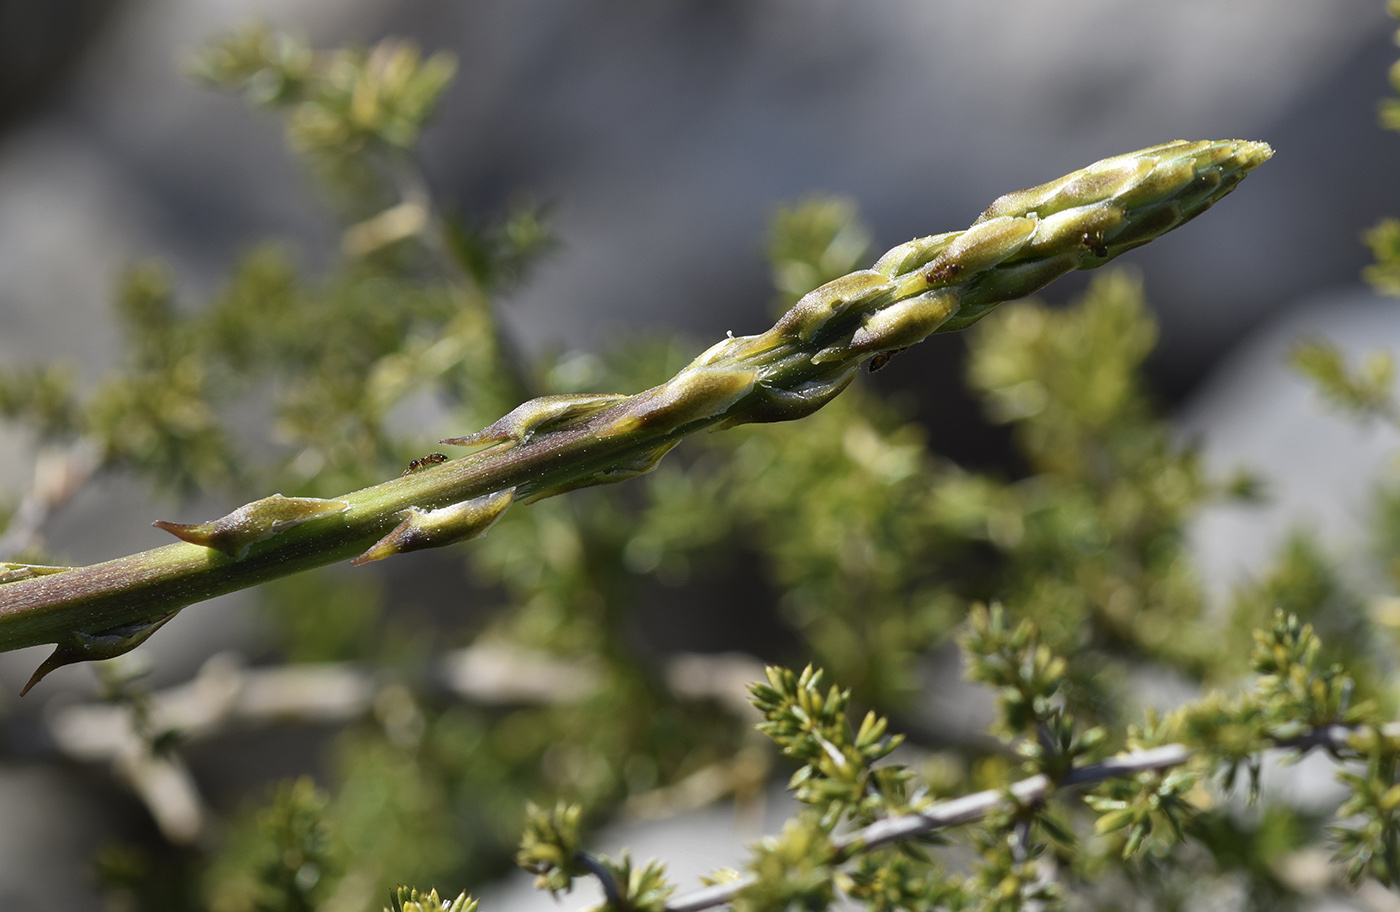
xmin=0 ymin=140 xmax=1273 ymax=686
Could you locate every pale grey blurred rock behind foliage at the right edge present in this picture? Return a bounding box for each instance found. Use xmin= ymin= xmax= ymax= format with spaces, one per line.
xmin=1179 ymin=287 xmax=1400 ymax=595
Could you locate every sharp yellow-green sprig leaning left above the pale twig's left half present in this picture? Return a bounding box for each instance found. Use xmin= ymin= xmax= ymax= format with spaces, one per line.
xmin=749 ymin=665 xmax=911 ymax=829
